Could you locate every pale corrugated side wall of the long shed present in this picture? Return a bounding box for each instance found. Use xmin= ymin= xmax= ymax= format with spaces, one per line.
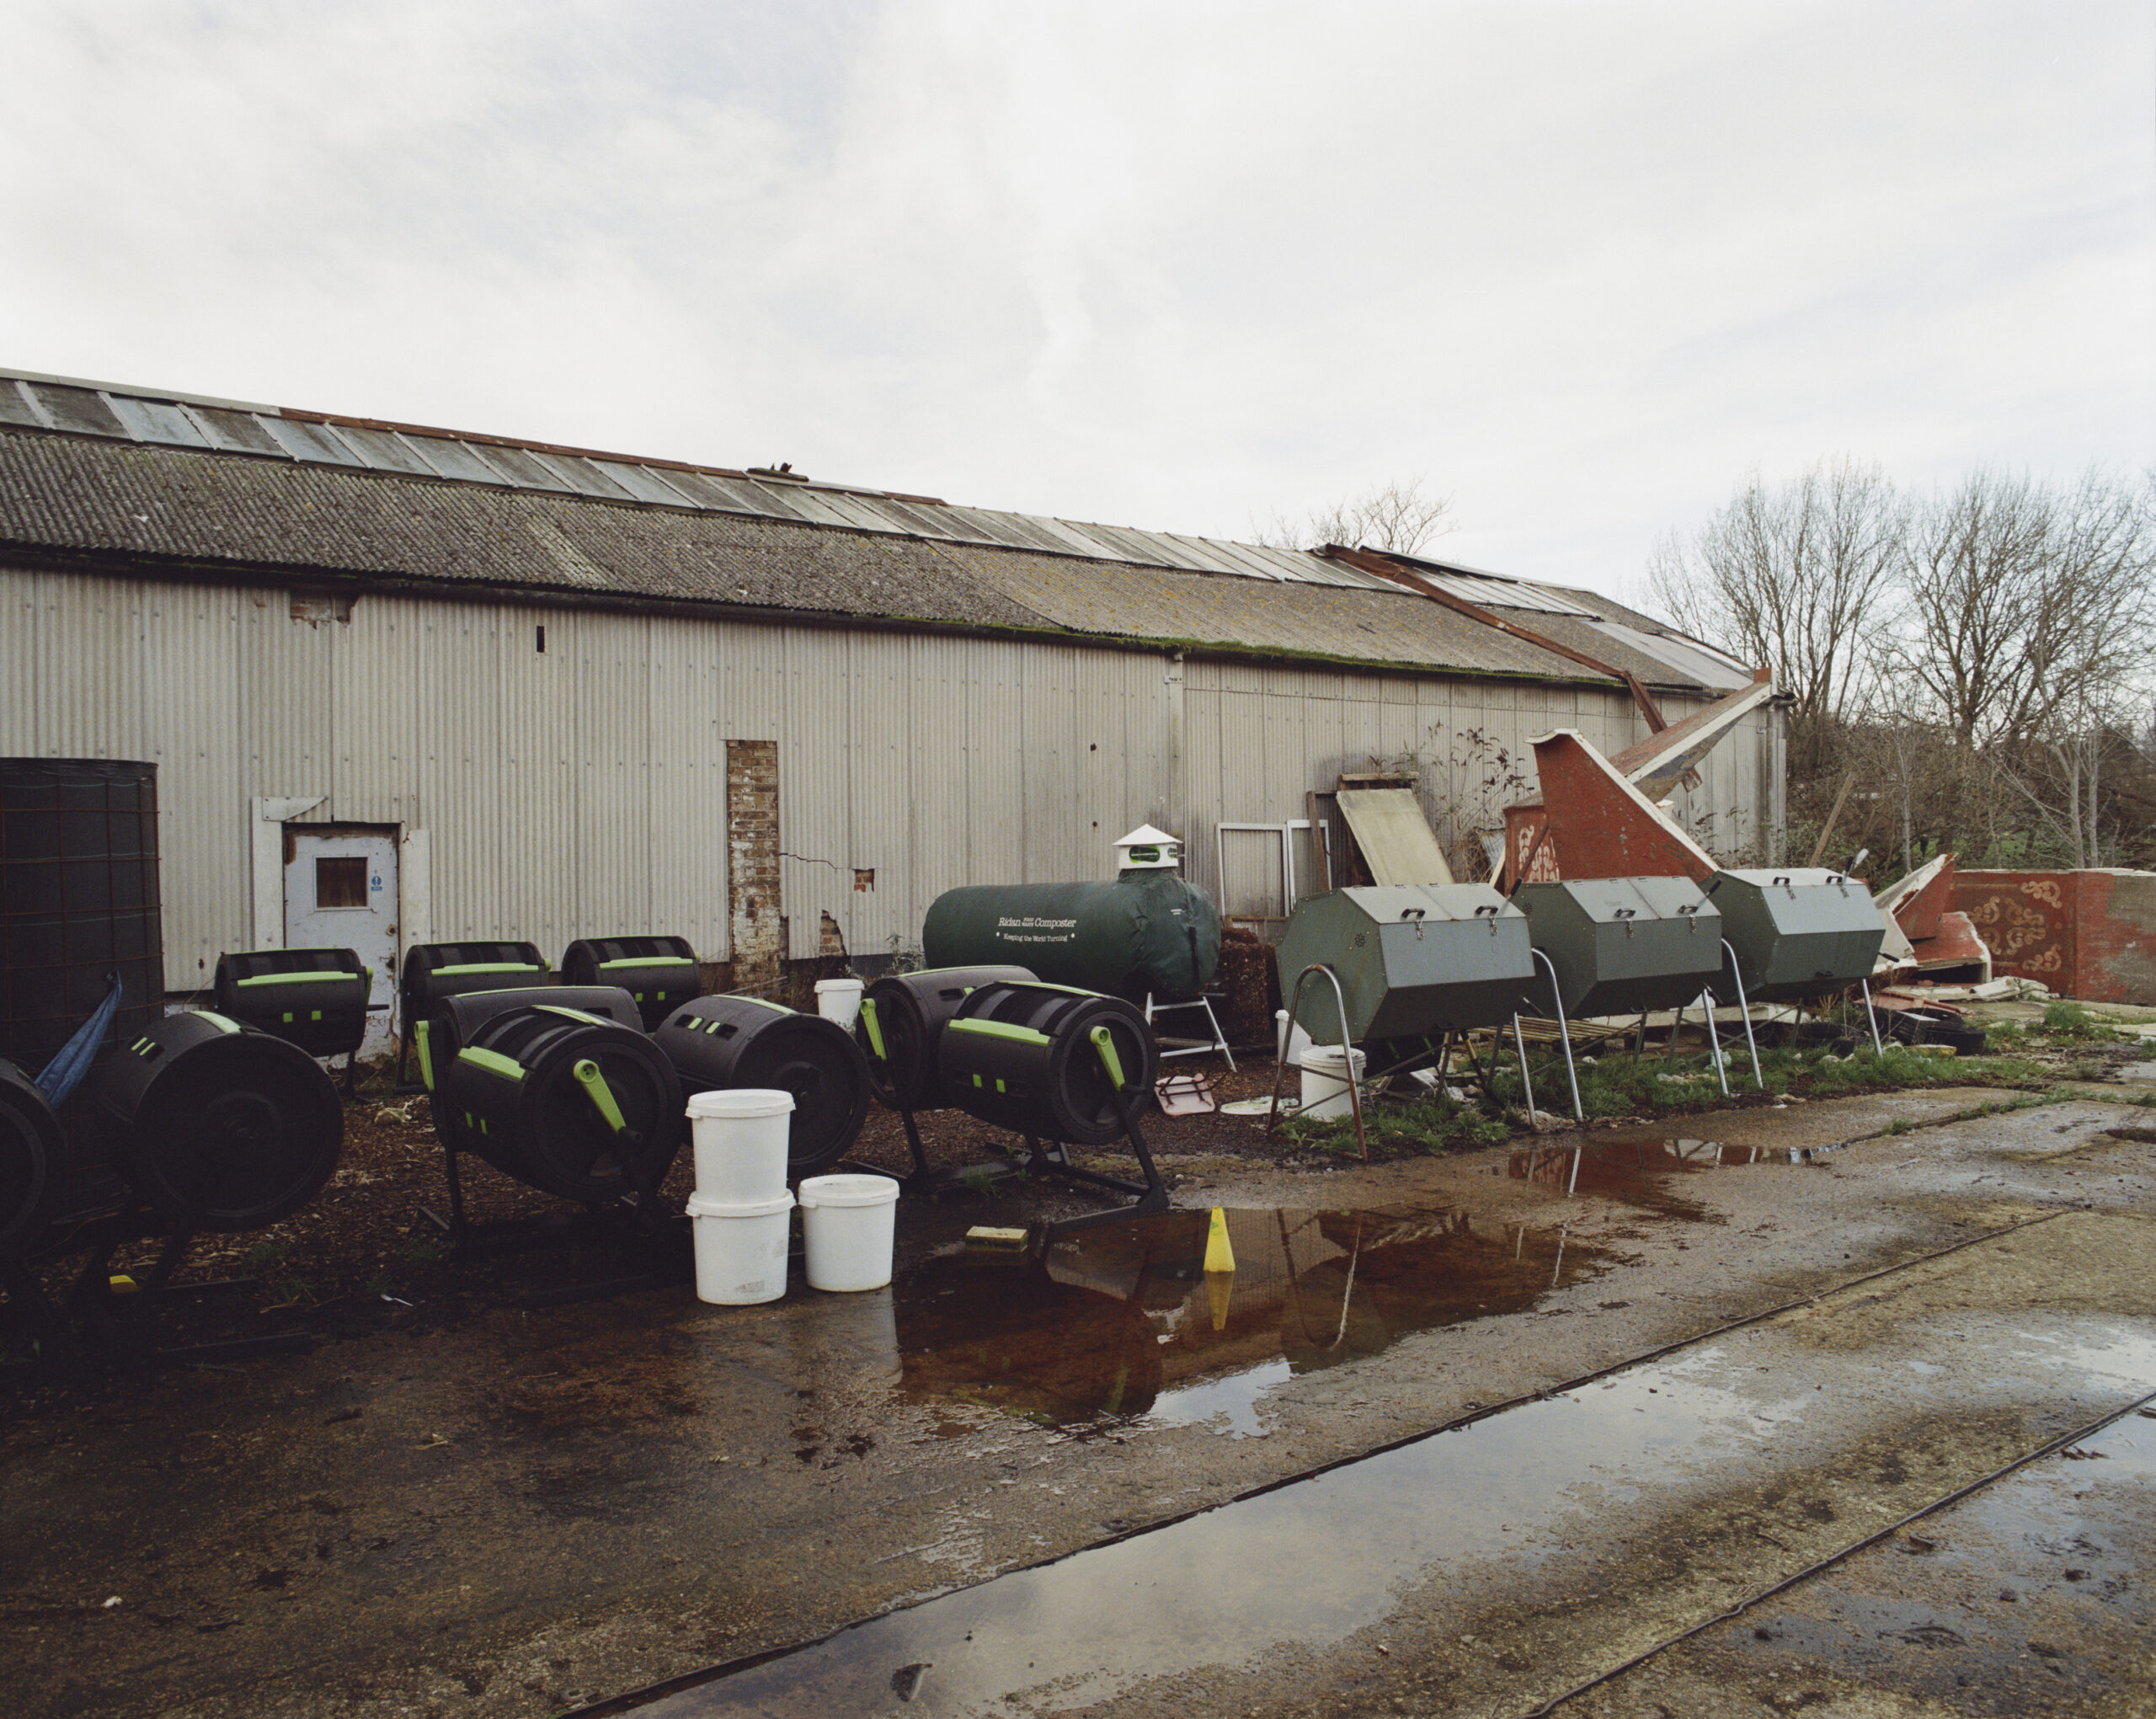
xmin=0 ymin=569 xmax=1764 ymax=990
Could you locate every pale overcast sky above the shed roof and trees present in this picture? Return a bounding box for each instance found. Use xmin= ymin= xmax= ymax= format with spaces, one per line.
xmin=0 ymin=0 xmax=2156 ymax=593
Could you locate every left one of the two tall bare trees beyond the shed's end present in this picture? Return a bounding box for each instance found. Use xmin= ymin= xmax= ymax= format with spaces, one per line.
xmin=1647 ymin=459 xmax=1908 ymax=774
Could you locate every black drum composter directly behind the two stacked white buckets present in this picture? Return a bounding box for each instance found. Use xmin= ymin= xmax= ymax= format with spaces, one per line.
xmin=651 ymin=996 xmax=869 ymax=1177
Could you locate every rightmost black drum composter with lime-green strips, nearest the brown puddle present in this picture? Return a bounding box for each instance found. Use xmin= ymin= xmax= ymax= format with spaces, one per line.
xmin=936 ymin=984 xmax=1158 ymax=1145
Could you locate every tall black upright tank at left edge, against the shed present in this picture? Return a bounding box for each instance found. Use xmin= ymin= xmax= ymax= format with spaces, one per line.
xmin=0 ymin=757 xmax=164 ymax=1074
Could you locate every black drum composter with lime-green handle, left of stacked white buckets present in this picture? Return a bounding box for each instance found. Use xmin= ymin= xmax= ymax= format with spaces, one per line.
xmin=434 ymin=992 xmax=684 ymax=1206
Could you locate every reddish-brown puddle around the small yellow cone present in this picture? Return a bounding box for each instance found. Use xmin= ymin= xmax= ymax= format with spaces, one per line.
xmin=893 ymin=1210 xmax=1602 ymax=1434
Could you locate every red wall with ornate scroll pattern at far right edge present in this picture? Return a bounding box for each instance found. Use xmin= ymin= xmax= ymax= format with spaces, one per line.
xmin=1953 ymin=872 xmax=2156 ymax=1003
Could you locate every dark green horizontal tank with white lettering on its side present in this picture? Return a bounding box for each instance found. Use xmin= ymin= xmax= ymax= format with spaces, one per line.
xmin=921 ymin=869 xmax=1220 ymax=1005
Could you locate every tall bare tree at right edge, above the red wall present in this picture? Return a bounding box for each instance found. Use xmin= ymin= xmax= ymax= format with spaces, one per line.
xmin=1895 ymin=470 xmax=2156 ymax=753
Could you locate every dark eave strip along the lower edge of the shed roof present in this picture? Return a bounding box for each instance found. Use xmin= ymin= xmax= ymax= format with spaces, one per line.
xmin=0 ymin=537 xmax=1664 ymax=692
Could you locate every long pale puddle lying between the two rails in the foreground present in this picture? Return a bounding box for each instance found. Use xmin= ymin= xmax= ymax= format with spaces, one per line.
xmin=616 ymin=1348 xmax=2156 ymax=1719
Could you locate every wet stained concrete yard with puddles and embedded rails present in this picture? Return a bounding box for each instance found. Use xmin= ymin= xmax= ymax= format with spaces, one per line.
xmin=0 ymin=1065 xmax=2156 ymax=1719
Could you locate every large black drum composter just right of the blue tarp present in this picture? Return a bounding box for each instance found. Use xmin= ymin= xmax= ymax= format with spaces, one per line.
xmin=97 ymin=1009 xmax=345 ymax=1230
